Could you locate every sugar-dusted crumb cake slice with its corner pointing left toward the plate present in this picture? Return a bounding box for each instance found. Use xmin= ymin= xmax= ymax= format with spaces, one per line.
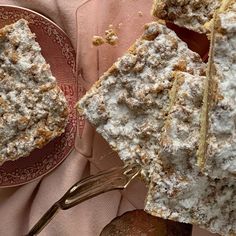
xmin=78 ymin=22 xmax=205 ymax=180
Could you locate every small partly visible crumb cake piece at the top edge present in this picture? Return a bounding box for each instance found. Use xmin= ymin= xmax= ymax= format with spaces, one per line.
xmin=152 ymin=0 xmax=222 ymax=33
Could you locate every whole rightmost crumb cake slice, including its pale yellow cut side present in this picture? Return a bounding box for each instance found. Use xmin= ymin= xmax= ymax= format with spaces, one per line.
xmin=198 ymin=1 xmax=236 ymax=178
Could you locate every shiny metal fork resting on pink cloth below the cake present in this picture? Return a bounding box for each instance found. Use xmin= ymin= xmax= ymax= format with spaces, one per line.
xmin=26 ymin=164 xmax=141 ymax=236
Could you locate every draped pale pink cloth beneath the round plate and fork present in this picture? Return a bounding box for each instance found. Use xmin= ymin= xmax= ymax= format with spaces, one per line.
xmin=0 ymin=0 xmax=218 ymax=236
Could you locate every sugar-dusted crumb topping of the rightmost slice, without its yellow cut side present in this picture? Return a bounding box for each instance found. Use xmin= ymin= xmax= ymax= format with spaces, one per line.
xmin=205 ymin=3 xmax=236 ymax=178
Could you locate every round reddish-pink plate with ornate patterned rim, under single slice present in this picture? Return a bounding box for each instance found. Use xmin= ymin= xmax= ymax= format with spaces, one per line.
xmin=0 ymin=6 xmax=78 ymax=187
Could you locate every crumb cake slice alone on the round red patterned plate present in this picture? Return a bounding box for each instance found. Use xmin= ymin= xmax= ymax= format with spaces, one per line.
xmin=0 ymin=19 xmax=68 ymax=165
